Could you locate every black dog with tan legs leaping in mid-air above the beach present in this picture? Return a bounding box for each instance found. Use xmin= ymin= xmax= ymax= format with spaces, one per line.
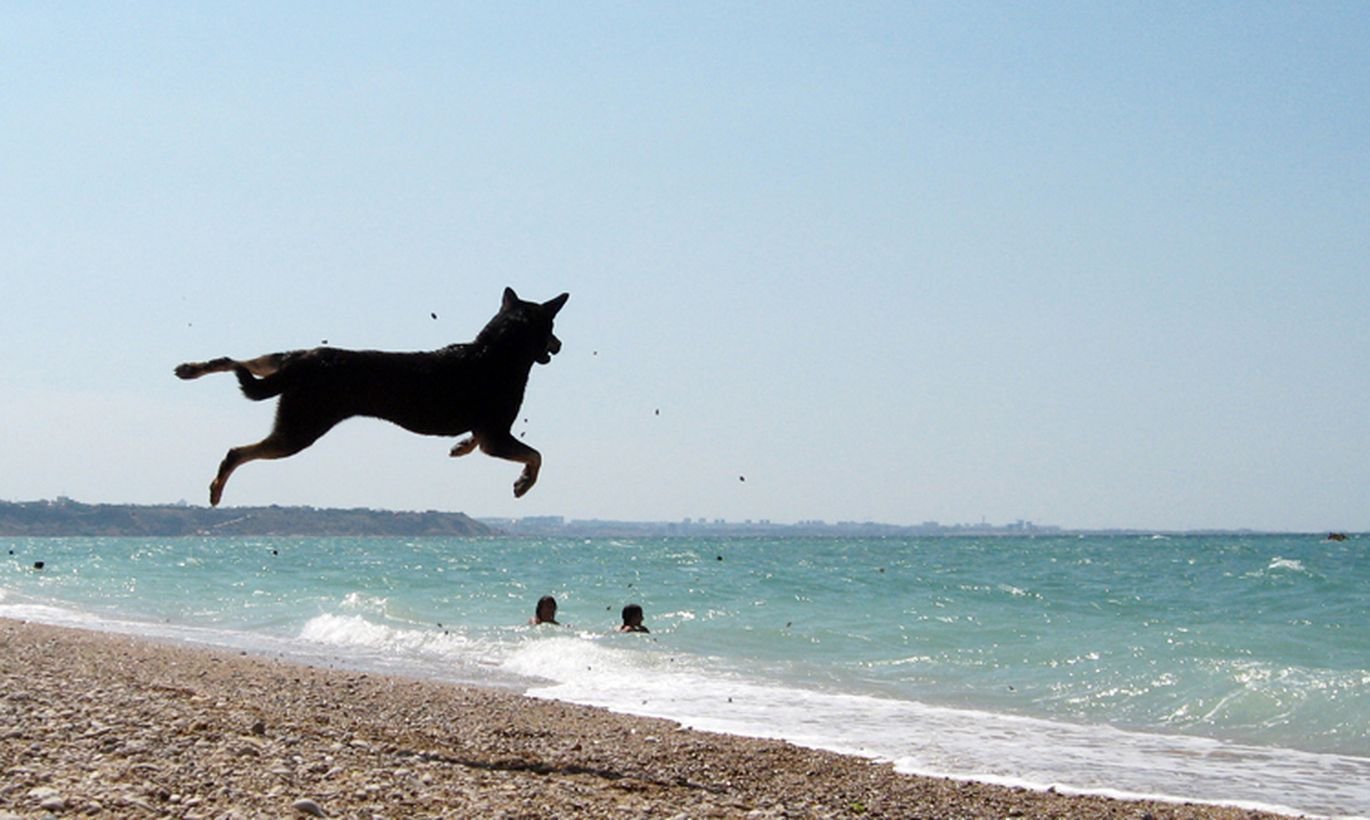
xmin=175 ymin=287 xmax=570 ymax=507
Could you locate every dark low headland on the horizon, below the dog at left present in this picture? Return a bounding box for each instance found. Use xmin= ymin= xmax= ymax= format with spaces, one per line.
xmin=0 ymin=498 xmax=495 ymax=537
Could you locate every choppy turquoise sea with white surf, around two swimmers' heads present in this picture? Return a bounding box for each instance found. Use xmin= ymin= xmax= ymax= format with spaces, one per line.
xmin=0 ymin=535 xmax=1370 ymax=816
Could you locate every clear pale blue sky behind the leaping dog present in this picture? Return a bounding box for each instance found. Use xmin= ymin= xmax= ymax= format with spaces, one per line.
xmin=0 ymin=1 xmax=1370 ymax=530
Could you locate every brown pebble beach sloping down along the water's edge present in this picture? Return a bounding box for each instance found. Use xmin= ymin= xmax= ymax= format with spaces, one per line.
xmin=0 ymin=619 xmax=1278 ymax=820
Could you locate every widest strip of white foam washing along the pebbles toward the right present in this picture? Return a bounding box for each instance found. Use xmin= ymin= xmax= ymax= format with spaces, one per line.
xmin=508 ymin=639 xmax=1370 ymax=816
